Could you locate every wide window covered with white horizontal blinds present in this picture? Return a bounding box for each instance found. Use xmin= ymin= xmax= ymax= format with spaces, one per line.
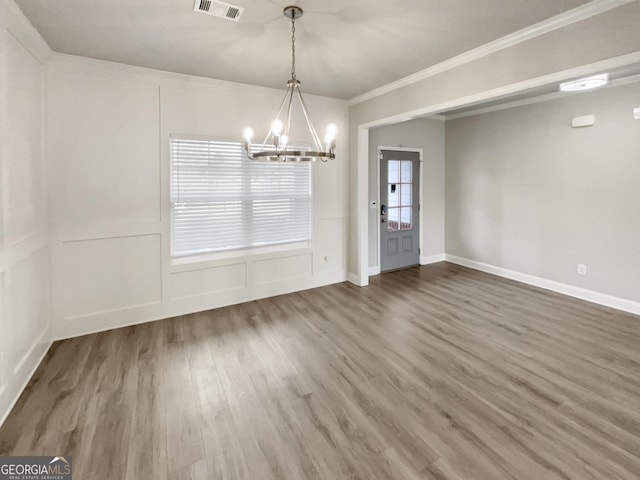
xmin=171 ymin=138 xmax=311 ymax=257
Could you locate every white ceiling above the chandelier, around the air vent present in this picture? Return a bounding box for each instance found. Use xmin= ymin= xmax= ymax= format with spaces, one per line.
xmin=16 ymin=0 xmax=589 ymax=98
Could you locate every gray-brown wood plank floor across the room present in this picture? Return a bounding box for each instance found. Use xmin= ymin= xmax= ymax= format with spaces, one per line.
xmin=0 ymin=263 xmax=640 ymax=480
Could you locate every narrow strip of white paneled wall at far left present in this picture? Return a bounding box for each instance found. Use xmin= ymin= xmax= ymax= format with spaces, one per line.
xmin=0 ymin=0 xmax=51 ymax=424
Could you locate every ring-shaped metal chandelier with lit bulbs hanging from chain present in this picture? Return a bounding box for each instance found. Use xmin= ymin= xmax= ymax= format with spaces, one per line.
xmin=243 ymin=6 xmax=338 ymax=162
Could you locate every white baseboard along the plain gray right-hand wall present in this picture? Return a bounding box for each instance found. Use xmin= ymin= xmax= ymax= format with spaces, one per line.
xmin=445 ymin=254 xmax=640 ymax=315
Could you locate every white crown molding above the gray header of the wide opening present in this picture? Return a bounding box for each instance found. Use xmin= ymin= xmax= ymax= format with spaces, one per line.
xmin=347 ymin=0 xmax=636 ymax=106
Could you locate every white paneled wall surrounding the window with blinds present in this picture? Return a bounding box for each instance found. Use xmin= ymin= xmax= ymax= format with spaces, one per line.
xmin=48 ymin=54 xmax=348 ymax=338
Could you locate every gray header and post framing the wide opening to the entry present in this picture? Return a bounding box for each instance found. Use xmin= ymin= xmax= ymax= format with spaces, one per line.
xmin=348 ymin=1 xmax=640 ymax=280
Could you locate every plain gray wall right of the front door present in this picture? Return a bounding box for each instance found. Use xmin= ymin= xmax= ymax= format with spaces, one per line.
xmin=446 ymin=83 xmax=640 ymax=301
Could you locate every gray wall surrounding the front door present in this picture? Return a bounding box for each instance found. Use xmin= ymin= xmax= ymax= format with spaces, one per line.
xmin=369 ymin=119 xmax=444 ymax=267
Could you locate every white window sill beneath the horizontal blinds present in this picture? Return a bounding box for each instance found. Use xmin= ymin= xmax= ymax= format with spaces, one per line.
xmin=171 ymin=240 xmax=311 ymax=273
